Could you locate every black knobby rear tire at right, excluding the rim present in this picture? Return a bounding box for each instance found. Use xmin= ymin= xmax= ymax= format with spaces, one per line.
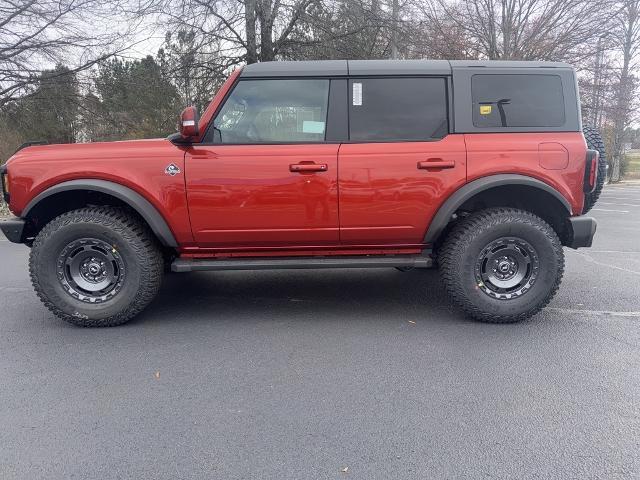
xmin=438 ymin=208 xmax=564 ymax=323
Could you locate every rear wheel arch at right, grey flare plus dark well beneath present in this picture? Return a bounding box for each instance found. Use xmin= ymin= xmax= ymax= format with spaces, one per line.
xmin=424 ymin=174 xmax=572 ymax=244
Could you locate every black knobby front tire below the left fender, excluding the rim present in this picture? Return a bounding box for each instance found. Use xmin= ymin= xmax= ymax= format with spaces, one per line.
xmin=29 ymin=207 xmax=163 ymax=327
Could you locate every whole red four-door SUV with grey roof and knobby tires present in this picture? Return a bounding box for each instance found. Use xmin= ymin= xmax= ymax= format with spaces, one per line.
xmin=0 ymin=60 xmax=602 ymax=326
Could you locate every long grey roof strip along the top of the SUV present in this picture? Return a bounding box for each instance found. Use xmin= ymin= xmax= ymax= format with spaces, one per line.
xmin=241 ymin=60 xmax=572 ymax=77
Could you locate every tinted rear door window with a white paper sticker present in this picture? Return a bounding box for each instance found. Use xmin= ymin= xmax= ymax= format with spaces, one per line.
xmin=349 ymin=78 xmax=448 ymax=142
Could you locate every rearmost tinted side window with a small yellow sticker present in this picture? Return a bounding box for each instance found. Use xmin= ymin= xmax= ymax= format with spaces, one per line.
xmin=471 ymin=75 xmax=565 ymax=128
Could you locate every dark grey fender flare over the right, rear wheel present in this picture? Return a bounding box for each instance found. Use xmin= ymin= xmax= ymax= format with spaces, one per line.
xmin=424 ymin=173 xmax=571 ymax=243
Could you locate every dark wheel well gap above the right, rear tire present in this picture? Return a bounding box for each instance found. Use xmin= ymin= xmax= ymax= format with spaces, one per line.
xmin=436 ymin=185 xmax=573 ymax=245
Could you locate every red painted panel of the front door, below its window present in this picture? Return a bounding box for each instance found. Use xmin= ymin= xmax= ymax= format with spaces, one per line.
xmin=185 ymin=144 xmax=339 ymax=247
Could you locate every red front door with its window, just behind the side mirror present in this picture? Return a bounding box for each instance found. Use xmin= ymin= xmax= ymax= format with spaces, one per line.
xmin=185 ymin=78 xmax=339 ymax=248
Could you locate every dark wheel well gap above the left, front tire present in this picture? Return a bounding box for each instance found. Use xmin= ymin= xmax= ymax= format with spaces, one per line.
xmin=23 ymin=189 xmax=173 ymax=254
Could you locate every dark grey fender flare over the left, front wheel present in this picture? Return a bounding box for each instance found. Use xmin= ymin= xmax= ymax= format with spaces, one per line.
xmin=22 ymin=179 xmax=178 ymax=248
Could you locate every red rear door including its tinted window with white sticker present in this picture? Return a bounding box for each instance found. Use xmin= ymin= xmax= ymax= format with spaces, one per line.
xmin=338 ymin=77 xmax=466 ymax=245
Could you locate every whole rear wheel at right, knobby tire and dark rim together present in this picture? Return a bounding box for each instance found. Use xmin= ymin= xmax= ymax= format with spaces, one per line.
xmin=438 ymin=208 xmax=564 ymax=323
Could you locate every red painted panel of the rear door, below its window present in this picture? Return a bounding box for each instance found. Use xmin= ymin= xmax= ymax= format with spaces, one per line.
xmin=338 ymin=135 xmax=467 ymax=244
